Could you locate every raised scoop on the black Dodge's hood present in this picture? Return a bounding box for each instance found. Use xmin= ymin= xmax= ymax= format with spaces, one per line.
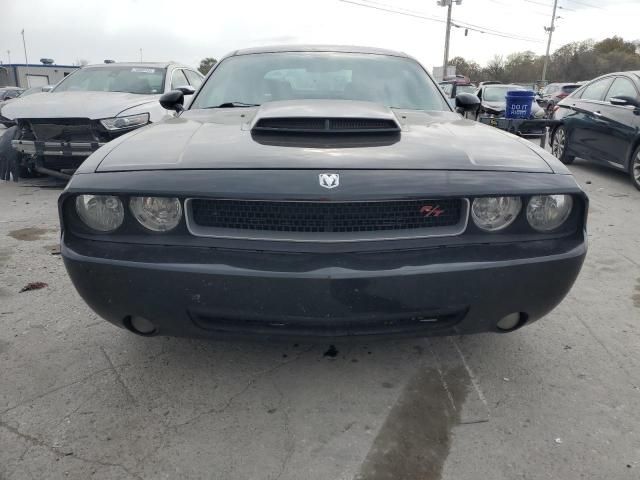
xmin=251 ymin=100 xmax=400 ymax=134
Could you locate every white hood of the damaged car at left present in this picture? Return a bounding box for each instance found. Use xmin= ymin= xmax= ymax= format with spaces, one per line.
xmin=2 ymin=92 xmax=160 ymax=120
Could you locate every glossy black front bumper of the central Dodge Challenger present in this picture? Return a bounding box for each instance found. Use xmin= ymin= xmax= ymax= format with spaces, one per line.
xmin=62 ymin=234 xmax=586 ymax=338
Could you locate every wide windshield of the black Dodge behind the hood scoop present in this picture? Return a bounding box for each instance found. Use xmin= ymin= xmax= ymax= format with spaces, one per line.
xmin=192 ymin=52 xmax=449 ymax=111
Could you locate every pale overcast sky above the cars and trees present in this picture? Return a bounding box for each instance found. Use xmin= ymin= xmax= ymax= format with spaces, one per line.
xmin=0 ymin=0 xmax=640 ymax=69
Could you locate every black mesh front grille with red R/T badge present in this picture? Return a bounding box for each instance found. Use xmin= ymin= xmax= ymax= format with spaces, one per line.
xmin=188 ymin=199 xmax=466 ymax=240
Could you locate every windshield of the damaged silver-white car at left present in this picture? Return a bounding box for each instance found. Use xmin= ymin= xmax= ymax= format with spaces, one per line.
xmin=53 ymin=66 xmax=165 ymax=95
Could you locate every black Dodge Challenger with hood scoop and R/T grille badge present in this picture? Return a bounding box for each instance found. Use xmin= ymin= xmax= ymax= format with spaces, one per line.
xmin=59 ymin=46 xmax=587 ymax=338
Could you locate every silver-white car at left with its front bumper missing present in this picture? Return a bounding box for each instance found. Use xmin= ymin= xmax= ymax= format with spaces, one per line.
xmin=0 ymin=63 xmax=204 ymax=179
